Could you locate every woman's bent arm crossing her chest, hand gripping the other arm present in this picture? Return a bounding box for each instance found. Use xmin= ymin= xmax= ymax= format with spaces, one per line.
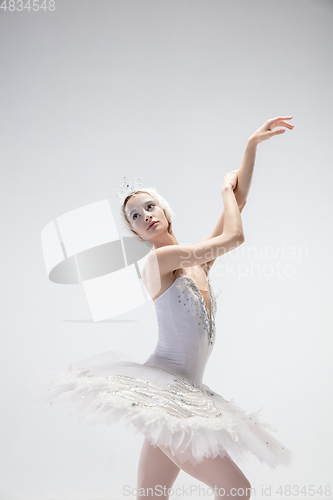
xmin=149 ymin=174 xmax=245 ymax=276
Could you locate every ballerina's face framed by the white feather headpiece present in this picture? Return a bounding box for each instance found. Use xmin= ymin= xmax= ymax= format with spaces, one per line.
xmin=125 ymin=193 xmax=169 ymax=240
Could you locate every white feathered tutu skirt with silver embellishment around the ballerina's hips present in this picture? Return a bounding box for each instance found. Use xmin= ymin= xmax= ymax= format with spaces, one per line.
xmin=28 ymin=351 xmax=294 ymax=469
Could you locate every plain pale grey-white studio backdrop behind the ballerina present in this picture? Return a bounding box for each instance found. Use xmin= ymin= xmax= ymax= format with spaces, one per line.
xmin=0 ymin=0 xmax=333 ymax=500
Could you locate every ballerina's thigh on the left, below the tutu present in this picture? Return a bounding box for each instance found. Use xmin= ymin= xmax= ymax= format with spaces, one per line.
xmin=137 ymin=437 xmax=180 ymax=490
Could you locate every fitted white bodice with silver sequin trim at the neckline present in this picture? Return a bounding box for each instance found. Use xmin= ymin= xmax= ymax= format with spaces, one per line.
xmin=144 ymin=274 xmax=216 ymax=387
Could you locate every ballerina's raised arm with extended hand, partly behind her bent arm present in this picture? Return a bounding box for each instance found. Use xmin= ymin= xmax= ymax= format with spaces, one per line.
xmin=203 ymin=116 xmax=294 ymax=241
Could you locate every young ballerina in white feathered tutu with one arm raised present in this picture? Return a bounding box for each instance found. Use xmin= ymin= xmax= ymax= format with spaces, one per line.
xmin=30 ymin=117 xmax=293 ymax=500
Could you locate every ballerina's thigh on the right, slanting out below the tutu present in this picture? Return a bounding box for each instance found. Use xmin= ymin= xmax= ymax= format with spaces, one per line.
xmin=161 ymin=448 xmax=251 ymax=494
